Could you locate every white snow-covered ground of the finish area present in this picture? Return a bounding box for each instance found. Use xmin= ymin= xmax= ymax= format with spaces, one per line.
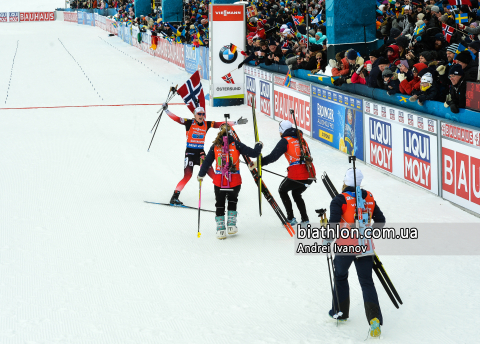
xmin=0 ymin=22 xmax=480 ymax=343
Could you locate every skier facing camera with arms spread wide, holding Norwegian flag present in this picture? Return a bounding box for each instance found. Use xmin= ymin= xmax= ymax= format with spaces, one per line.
xmin=162 ymin=104 xmax=248 ymax=206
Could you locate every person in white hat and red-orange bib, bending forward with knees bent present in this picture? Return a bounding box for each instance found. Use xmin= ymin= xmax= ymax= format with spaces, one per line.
xmin=250 ymin=120 xmax=315 ymax=226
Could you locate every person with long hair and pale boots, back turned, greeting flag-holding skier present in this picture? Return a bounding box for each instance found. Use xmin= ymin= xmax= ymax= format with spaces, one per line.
xmin=197 ymin=122 xmax=263 ymax=239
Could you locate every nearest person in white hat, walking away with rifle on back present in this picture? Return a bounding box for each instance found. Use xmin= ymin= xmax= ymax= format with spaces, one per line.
xmin=328 ymin=168 xmax=385 ymax=337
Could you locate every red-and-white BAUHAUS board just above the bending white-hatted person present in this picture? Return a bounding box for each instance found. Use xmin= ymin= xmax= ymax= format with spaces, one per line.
xmin=274 ymin=86 xmax=312 ymax=136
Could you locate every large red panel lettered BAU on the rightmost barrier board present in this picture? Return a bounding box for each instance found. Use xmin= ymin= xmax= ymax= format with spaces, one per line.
xmin=442 ymin=147 xmax=480 ymax=207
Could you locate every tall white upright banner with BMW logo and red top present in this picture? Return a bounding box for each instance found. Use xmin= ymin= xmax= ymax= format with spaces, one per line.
xmin=209 ymin=4 xmax=246 ymax=106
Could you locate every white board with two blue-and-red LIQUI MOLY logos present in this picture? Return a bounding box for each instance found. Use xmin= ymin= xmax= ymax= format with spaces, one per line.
xmin=364 ymin=100 xmax=439 ymax=195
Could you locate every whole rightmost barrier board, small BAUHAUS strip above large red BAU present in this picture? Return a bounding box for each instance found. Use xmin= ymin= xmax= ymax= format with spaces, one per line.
xmin=441 ymin=121 xmax=480 ymax=214
